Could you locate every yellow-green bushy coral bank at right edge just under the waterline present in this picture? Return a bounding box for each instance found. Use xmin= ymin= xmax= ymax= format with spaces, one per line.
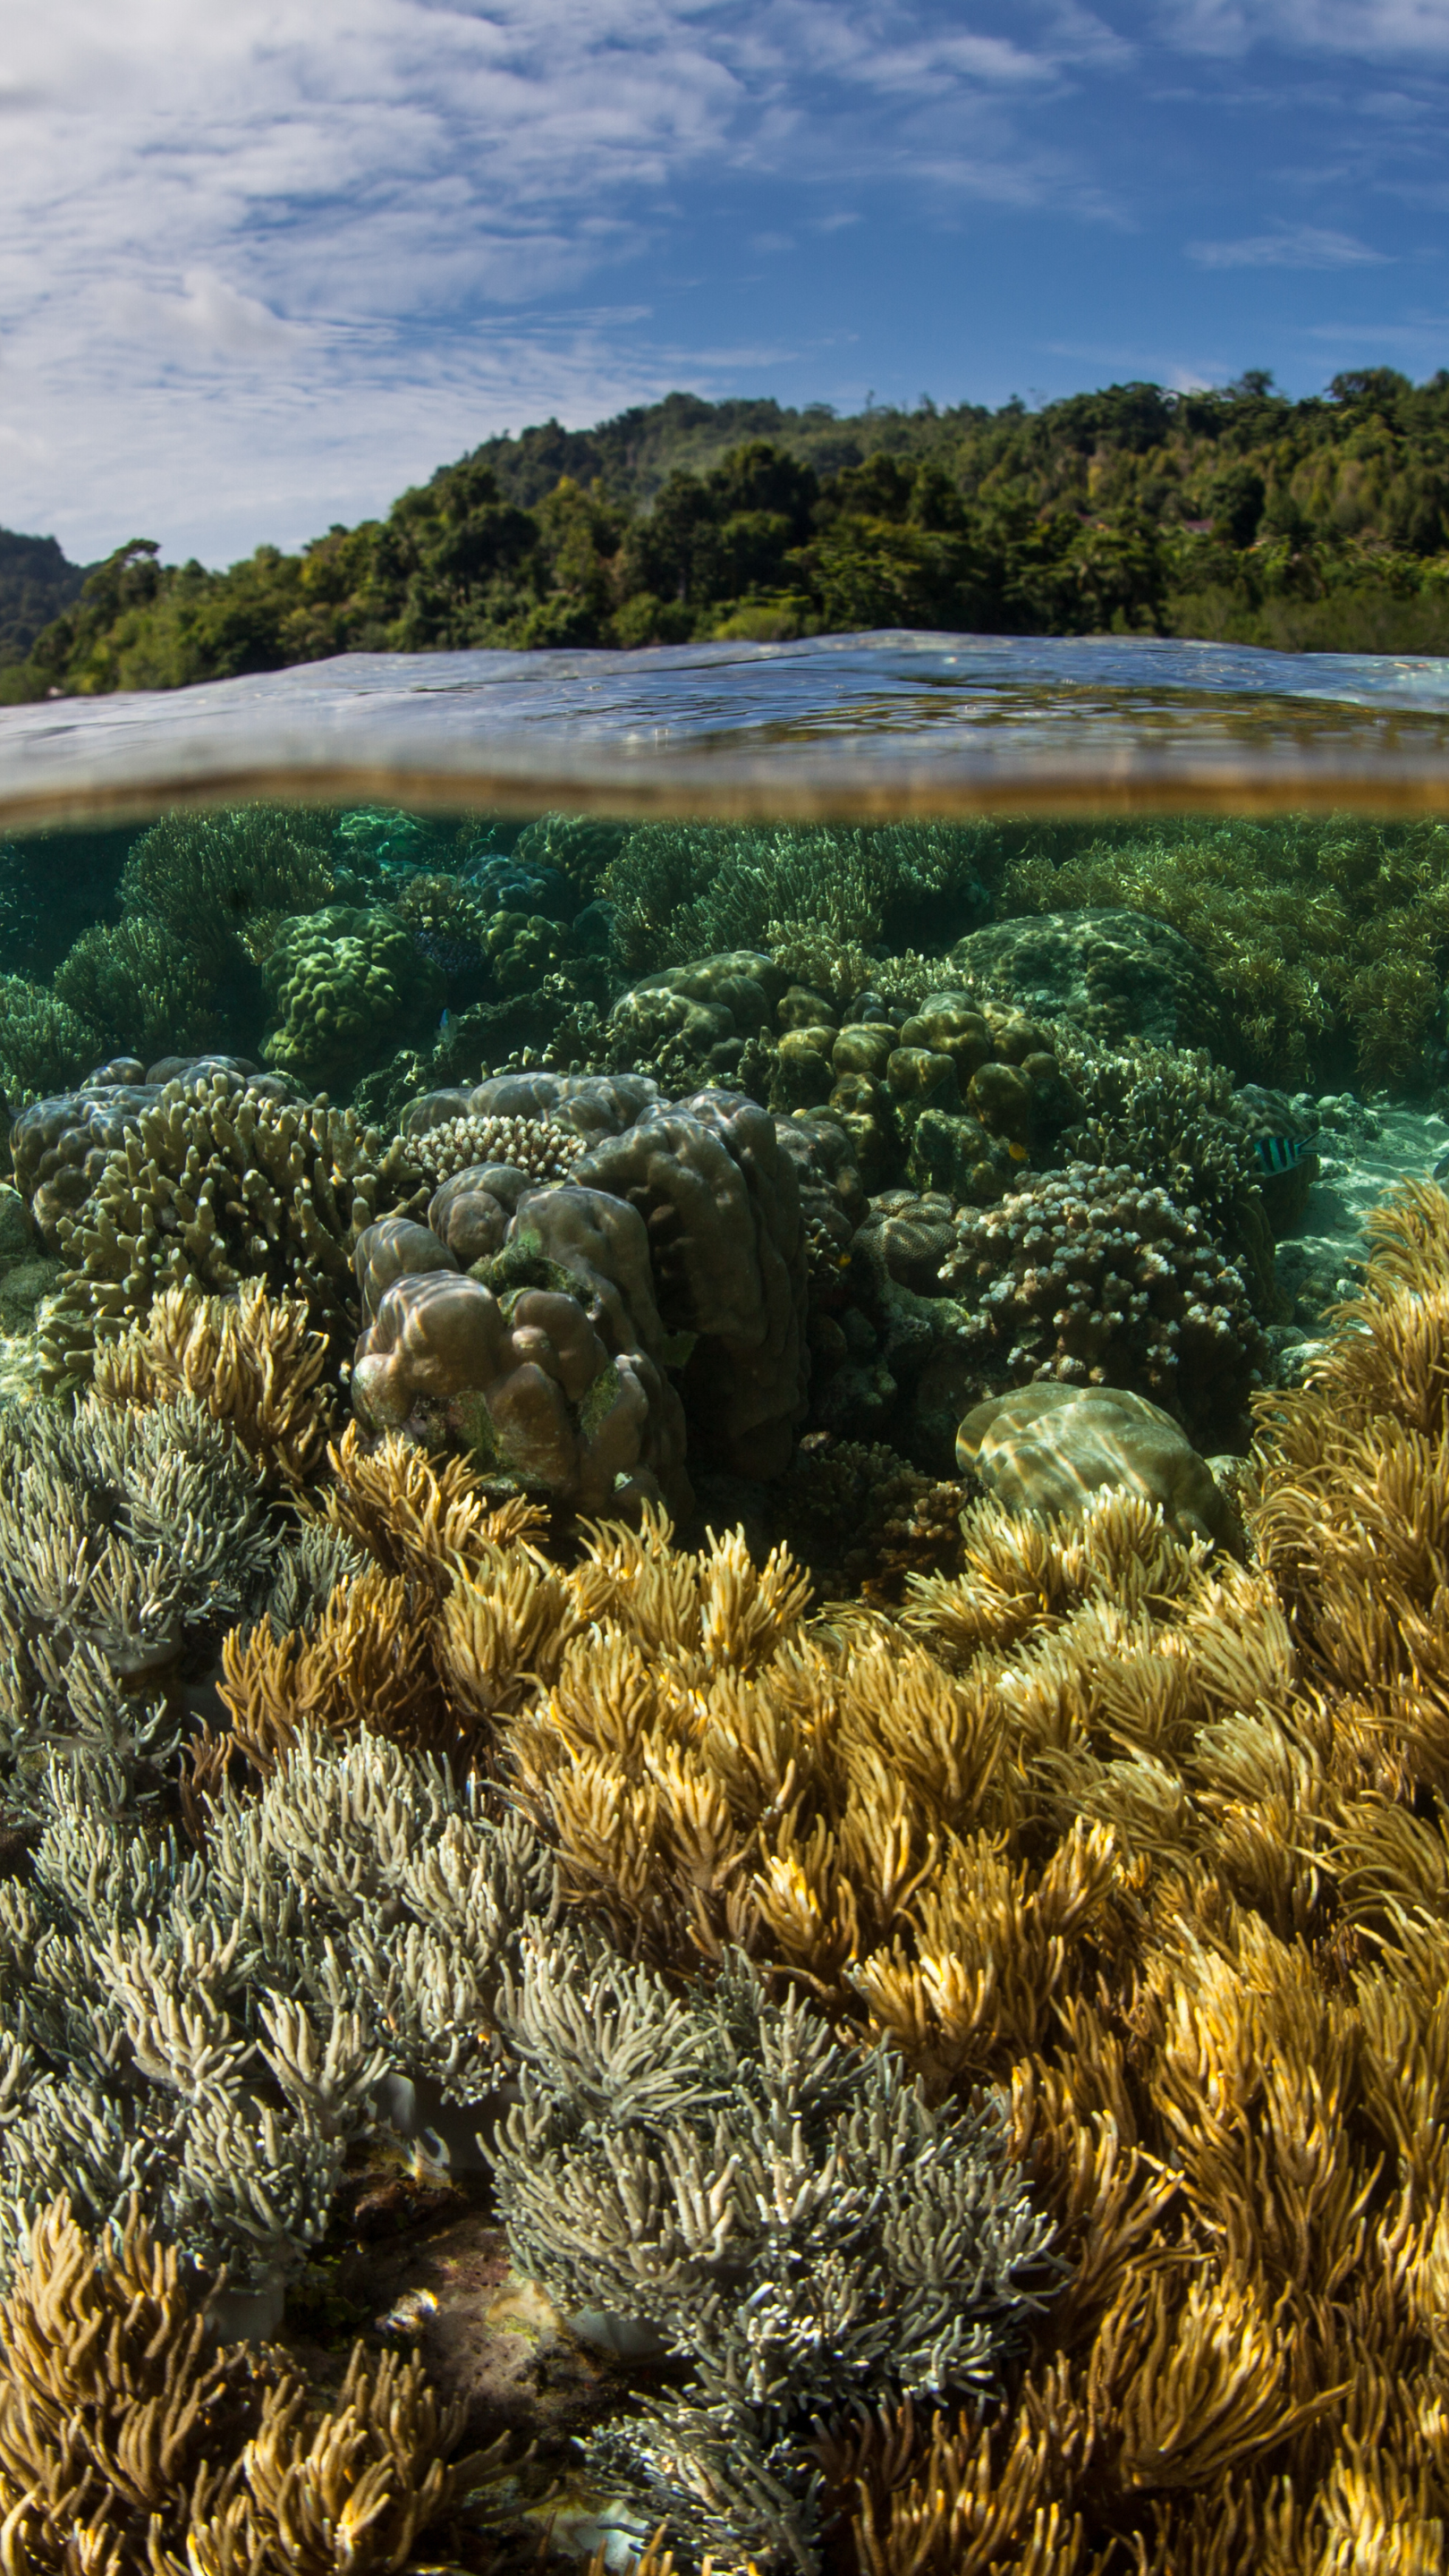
xmin=1003 ymin=814 xmax=1449 ymax=1089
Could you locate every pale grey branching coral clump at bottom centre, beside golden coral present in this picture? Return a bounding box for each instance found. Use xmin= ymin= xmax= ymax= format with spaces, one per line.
xmin=490 ymin=1937 xmax=1052 ymax=2568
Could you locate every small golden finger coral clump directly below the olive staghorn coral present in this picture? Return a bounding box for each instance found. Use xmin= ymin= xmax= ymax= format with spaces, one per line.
xmin=93 ymin=1280 xmax=333 ymax=1492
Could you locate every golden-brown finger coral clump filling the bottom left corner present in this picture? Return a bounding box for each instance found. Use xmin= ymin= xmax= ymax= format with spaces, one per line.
xmin=0 ymin=2198 xmax=500 ymax=2576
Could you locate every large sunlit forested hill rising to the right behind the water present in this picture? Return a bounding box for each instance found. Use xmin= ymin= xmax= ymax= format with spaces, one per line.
xmin=0 ymin=369 xmax=1449 ymax=698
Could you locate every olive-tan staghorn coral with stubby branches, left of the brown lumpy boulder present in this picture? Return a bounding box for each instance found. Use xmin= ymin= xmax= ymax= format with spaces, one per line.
xmin=41 ymin=1074 xmax=418 ymax=1385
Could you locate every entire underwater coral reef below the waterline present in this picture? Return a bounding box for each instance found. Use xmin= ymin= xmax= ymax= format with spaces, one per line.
xmin=0 ymin=811 xmax=1449 ymax=2576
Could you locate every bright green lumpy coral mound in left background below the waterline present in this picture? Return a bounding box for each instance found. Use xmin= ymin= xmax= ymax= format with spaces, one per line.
xmin=263 ymin=904 xmax=444 ymax=1089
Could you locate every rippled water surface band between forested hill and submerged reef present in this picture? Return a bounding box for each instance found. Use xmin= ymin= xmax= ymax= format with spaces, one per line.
xmin=0 ymin=633 xmax=1449 ymax=829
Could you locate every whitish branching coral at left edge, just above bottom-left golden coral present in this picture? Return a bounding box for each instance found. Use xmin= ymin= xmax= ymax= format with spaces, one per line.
xmin=0 ymin=1733 xmax=555 ymax=2290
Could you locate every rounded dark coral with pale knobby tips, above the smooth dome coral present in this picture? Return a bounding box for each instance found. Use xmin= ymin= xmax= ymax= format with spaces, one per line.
xmin=941 ymin=1162 xmax=1266 ymax=1437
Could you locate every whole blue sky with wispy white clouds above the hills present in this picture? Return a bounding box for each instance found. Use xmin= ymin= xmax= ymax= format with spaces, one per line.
xmin=0 ymin=0 xmax=1449 ymax=564
